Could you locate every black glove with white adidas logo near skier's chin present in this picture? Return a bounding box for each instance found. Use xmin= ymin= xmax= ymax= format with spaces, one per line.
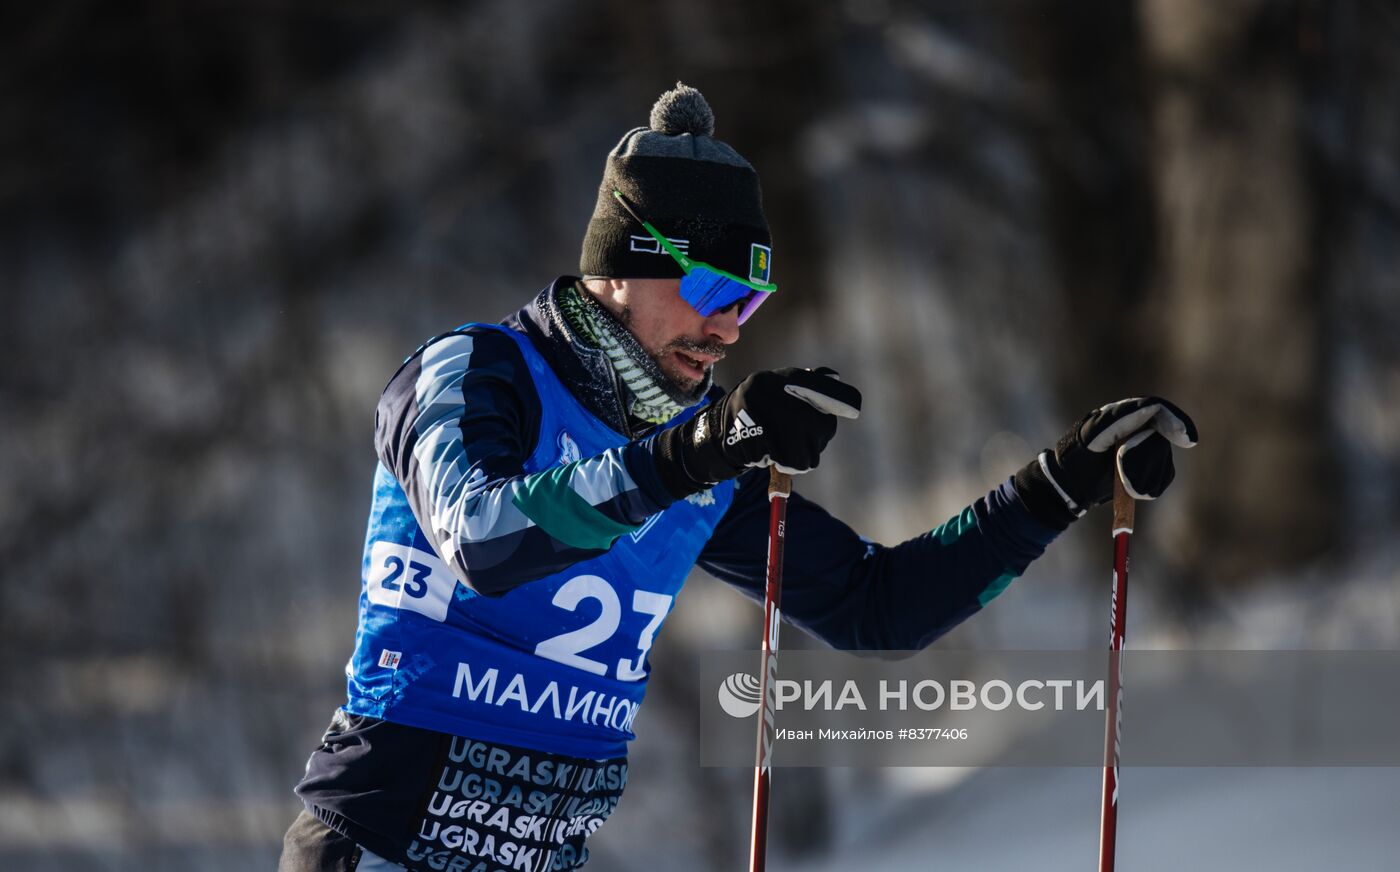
xmin=652 ymin=367 xmax=861 ymax=500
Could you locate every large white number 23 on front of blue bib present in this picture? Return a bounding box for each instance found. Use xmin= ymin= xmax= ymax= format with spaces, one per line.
xmin=535 ymin=575 xmax=672 ymax=682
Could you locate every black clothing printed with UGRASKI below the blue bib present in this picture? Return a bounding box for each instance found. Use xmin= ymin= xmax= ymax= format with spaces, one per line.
xmin=292 ymin=715 xmax=627 ymax=872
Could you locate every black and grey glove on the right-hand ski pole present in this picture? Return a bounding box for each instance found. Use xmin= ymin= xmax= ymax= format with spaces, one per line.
xmin=1014 ymin=396 xmax=1196 ymax=529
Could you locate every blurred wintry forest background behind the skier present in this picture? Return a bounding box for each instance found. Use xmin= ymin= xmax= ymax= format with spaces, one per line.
xmin=0 ymin=0 xmax=1400 ymax=869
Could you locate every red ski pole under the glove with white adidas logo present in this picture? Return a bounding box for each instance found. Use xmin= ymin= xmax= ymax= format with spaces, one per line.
xmin=749 ymin=466 xmax=792 ymax=872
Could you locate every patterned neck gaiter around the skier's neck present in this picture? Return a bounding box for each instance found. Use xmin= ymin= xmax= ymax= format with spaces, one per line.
xmin=556 ymin=284 xmax=711 ymax=424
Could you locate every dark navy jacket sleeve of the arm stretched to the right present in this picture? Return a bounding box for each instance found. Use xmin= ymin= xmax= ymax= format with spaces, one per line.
xmin=699 ymin=470 xmax=1058 ymax=651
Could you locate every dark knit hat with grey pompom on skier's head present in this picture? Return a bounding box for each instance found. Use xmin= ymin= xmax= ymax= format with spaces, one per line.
xmin=578 ymin=83 xmax=771 ymax=279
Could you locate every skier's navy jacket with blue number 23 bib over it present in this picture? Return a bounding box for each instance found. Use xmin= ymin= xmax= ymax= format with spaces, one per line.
xmin=298 ymin=277 xmax=1057 ymax=844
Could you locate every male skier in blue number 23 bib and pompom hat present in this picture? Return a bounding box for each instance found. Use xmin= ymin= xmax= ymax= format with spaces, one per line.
xmin=280 ymin=85 xmax=1196 ymax=872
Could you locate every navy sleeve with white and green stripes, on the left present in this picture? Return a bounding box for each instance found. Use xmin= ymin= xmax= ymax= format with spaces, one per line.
xmin=375 ymin=328 xmax=669 ymax=596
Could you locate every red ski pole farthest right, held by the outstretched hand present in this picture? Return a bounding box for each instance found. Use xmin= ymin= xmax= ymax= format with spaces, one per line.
xmin=1099 ymin=463 xmax=1135 ymax=872
